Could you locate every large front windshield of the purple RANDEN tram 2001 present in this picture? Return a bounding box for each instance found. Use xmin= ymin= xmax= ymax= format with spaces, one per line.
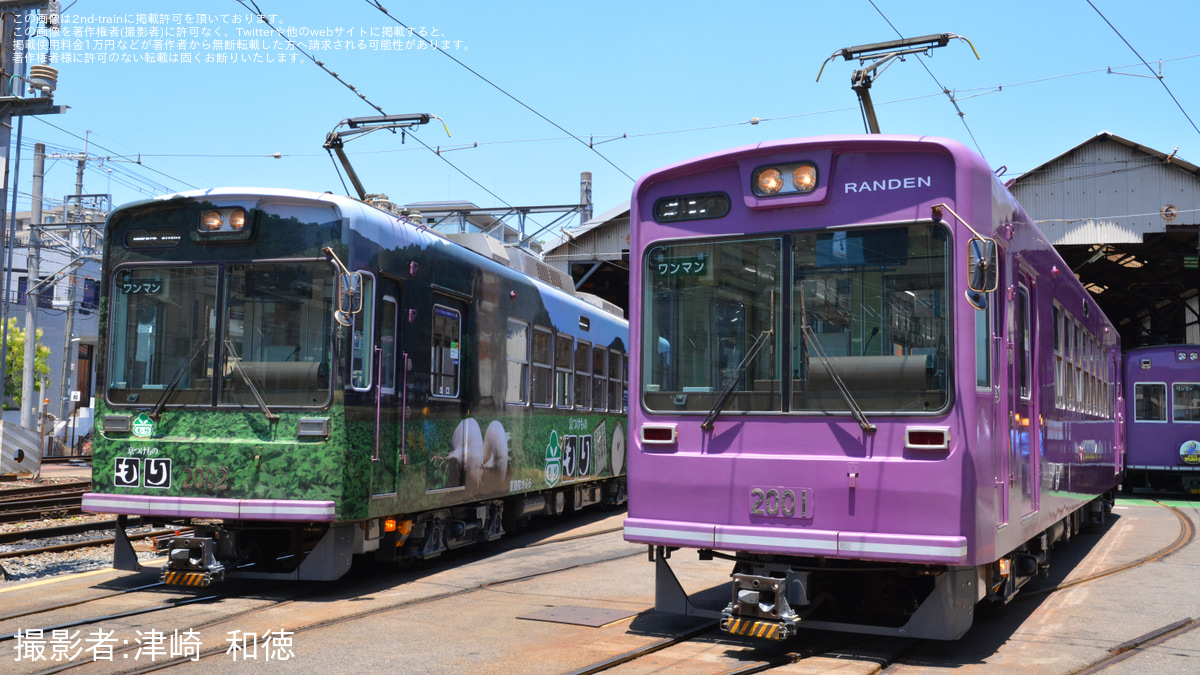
xmin=641 ymin=222 xmax=950 ymax=414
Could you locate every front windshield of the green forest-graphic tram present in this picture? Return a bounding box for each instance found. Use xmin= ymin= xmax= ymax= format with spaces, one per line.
xmin=108 ymin=262 xmax=334 ymax=407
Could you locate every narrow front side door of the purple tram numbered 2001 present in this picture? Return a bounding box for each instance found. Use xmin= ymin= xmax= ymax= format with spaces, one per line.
xmin=1008 ymin=274 xmax=1042 ymax=516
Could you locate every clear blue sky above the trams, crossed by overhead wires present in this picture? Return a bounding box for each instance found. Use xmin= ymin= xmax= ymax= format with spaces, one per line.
xmin=18 ymin=0 xmax=1200 ymax=236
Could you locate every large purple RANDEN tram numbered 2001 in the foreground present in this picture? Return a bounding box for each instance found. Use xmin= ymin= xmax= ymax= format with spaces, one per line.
xmin=624 ymin=136 xmax=1123 ymax=639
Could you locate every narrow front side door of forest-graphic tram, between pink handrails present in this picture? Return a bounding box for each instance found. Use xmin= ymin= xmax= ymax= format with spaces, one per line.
xmin=371 ymin=276 xmax=407 ymax=496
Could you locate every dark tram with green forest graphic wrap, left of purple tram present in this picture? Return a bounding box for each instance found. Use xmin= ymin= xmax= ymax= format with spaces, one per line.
xmin=84 ymin=189 xmax=628 ymax=585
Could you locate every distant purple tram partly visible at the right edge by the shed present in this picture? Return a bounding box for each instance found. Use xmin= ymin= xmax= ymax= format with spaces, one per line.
xmin=1122 ymin=345 xmax=1200 ymax=492
